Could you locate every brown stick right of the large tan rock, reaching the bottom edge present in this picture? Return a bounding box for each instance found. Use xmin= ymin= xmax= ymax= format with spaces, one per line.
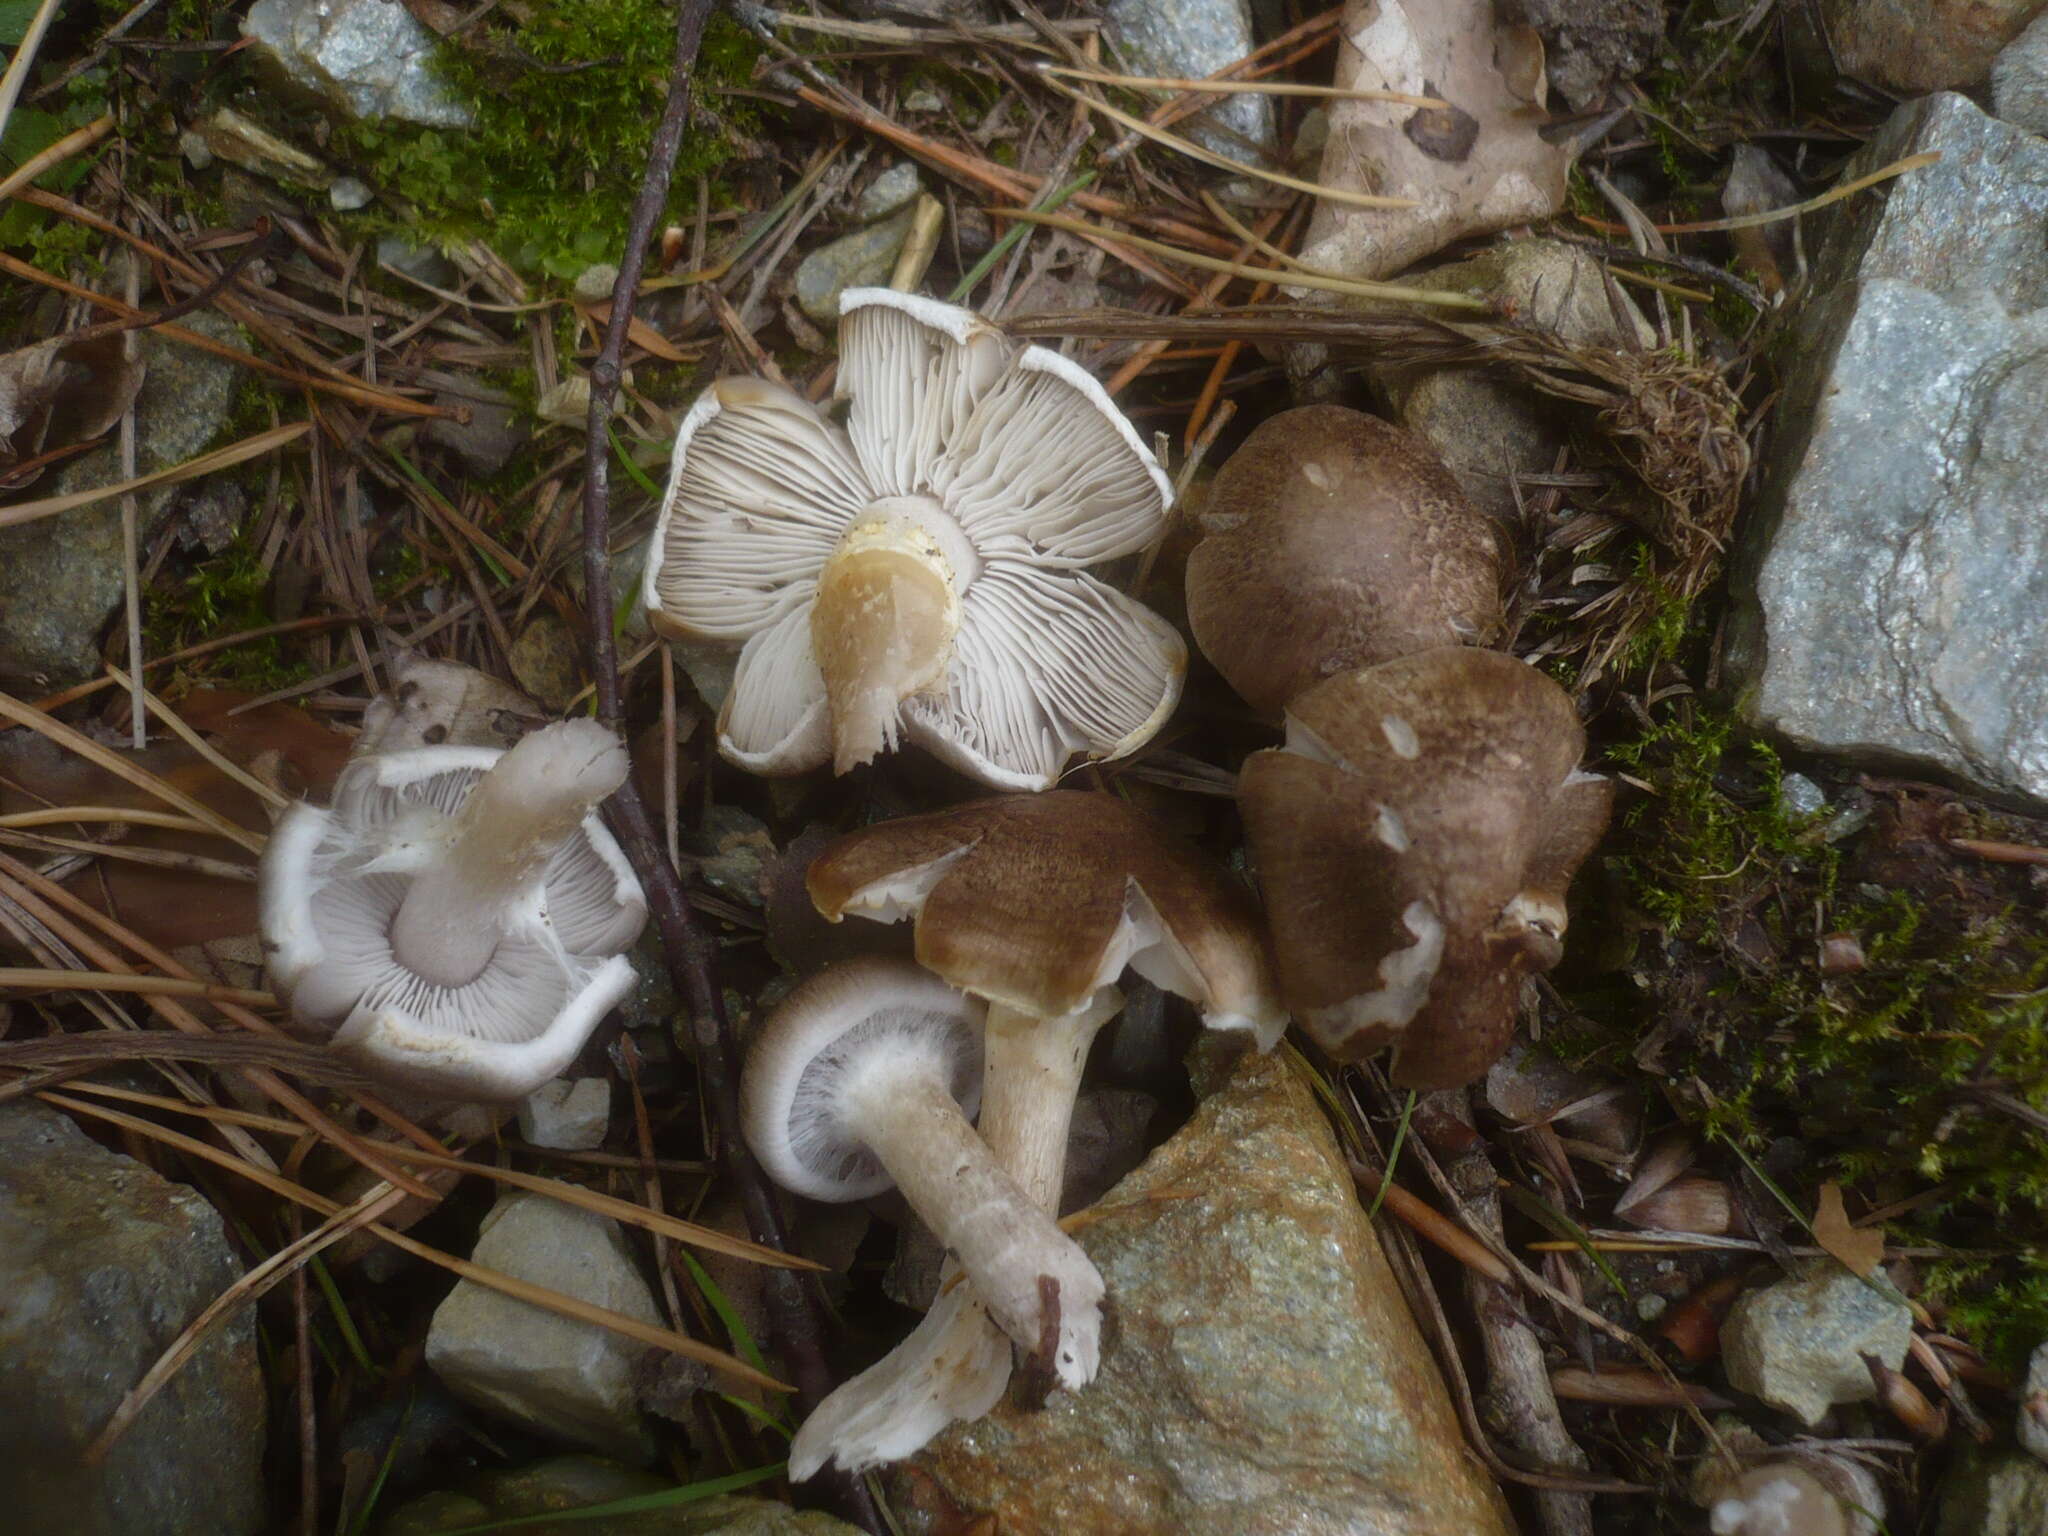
xmin=1415 ymin=1090 xmax=1593 ymax=1536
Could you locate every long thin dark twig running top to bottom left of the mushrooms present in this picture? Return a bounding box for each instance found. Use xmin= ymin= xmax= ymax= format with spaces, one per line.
xmin=584 ymin=0 xmax=883 ymax=1534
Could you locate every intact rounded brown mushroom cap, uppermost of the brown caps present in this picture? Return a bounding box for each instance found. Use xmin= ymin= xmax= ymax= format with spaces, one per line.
xmin=1188 ymin=406 xmax=1501 ymax=717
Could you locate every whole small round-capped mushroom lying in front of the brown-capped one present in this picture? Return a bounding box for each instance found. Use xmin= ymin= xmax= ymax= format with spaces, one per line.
xmin=741 ymin=958 xmax=1102 ymax=1372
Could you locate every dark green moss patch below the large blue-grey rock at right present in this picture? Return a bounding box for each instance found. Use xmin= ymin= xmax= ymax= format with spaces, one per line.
xmin=1579 ymin=700 xmax=2048 ymax=1364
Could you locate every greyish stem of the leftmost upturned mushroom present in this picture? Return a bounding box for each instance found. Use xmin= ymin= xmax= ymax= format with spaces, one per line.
xmin=391 ymin=721 xmax=629 ymax=987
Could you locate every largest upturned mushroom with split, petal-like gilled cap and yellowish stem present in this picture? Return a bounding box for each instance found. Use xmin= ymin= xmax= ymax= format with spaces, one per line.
xmin=641 ymin=289 xmax=1188 ymax=788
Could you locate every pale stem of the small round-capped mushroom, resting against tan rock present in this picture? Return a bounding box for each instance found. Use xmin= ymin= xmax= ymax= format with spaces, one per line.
xmin=846 ymin=1069 xmax=1102 ymax=1382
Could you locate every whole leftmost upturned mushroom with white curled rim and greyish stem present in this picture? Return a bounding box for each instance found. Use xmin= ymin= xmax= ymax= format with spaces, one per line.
xmin=260 ymin=721 xmax=647 ymax=1100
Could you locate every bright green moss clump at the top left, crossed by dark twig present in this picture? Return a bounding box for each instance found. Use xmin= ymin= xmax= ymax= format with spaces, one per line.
xmin=334 ymin=0 xmax=758 ymax=276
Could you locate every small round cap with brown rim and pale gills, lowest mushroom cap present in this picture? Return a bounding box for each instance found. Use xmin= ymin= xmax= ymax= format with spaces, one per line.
xmin=739 ymin=958 xmax=983 ymax=1200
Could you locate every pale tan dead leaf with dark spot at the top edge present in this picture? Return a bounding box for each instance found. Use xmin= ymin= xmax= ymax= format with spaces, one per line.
xmin=1300 ymin=0 xmax=1571 ymax=279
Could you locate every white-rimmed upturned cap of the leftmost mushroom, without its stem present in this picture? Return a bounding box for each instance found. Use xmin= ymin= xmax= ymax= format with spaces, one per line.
xmin=258 ymin=741 xmax=647 ymax=1100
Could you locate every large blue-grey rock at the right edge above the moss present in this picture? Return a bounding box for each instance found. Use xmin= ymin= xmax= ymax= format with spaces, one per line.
xmin=1729 ymin=94 xmax=2048 ymax=819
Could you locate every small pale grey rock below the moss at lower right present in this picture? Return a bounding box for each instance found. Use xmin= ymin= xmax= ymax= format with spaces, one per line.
xmin=1720 ymin=1260 xmax=1913 ymax=1427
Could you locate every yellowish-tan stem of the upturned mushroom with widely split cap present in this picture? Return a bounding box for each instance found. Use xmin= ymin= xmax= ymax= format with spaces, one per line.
xmin=811 ymin=512 xmax=971 ymax=774
